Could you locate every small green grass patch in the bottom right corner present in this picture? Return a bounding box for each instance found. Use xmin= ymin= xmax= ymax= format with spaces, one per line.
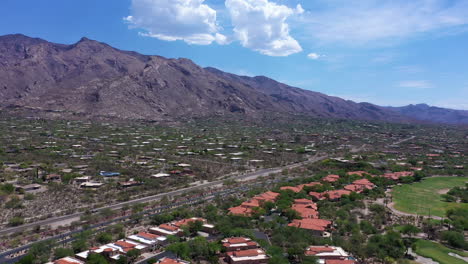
xmin=415 ymin=240 xmax=468 ymax=264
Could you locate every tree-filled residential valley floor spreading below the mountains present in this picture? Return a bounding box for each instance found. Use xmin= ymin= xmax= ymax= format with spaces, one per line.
xmin=0 ymin=116 xmax=468 ymax=264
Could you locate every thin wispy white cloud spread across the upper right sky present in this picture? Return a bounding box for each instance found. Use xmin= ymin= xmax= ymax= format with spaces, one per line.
xmin=303 ymin=0 xmax=468 ymax=44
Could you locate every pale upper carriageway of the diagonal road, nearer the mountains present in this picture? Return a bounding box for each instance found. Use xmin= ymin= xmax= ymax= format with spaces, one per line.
xmin=0 ymin=155 xmax=327 ymax=235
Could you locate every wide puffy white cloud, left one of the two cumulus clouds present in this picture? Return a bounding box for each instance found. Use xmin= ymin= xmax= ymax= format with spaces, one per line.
xmin=124 ymin=0 xmax=228 ymax=45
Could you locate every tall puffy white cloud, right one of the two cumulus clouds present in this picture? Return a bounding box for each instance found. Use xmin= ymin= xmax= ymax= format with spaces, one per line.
xmin=225 ymin=0 xmax=304 ymax=56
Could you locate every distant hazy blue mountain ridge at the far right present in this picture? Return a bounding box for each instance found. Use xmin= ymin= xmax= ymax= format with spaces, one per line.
xmin=387 ymin=104 xmax=468 ymax=124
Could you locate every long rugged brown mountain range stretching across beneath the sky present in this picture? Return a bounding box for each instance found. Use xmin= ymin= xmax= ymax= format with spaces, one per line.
xmin=0 ymin=34 xmax=468 ymax=124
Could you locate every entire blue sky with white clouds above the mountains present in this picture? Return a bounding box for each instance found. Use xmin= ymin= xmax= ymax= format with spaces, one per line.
xmin=0 ymin=0 xmax=468 ymax=109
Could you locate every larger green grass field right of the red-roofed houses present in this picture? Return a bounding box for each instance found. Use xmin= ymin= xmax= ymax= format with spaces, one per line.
xmin=392 ymin=177 xmax=468 ymax=217
